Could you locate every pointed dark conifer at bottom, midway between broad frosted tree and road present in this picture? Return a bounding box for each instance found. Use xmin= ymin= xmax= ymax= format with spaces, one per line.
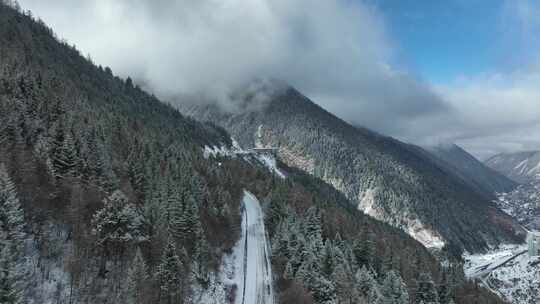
xmin=156 ymin=242 xmax=183 ymax=304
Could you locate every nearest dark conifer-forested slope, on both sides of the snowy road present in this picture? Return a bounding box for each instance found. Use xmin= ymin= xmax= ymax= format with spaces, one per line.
xmin=0 ymin=1 xmax=508 ymax=304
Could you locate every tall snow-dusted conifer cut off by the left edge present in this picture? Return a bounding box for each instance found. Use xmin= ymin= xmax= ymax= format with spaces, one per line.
xmin=0 ymin=164 xmax=26 ymax=304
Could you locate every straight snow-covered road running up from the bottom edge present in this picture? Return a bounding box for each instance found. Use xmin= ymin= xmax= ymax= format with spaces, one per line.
xmin=235 ymin=191 xmax=274 ymax=304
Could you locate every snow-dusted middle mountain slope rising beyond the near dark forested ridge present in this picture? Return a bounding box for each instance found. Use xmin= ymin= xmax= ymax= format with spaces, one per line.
xmin=183 ymin=84 xmax=521 ymax=251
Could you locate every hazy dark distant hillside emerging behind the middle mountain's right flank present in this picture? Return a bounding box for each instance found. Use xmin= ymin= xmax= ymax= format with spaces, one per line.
xmin=425 ymin=144 xmax=517 ymax=199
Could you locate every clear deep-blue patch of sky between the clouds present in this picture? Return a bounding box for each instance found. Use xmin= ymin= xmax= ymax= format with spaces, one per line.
xmin=374 ymin=0 xmax=508 ymax=84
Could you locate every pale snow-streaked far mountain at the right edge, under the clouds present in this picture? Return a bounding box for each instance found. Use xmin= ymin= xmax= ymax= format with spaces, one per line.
xmin=485 ymin=151 xmax=540 ymax=183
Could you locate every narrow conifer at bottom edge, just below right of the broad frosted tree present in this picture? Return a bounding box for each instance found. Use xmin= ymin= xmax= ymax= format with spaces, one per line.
xmin=127 ymin=248 xmax=149 ymax=304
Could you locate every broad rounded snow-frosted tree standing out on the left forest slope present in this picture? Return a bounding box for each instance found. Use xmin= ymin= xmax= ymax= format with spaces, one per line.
xmin=92 ymin=190 xmax=147 ymax=255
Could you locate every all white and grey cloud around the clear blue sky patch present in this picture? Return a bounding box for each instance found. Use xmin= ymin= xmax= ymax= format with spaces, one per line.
xmin=16 ymin=0 xmax=540 ymax=157
